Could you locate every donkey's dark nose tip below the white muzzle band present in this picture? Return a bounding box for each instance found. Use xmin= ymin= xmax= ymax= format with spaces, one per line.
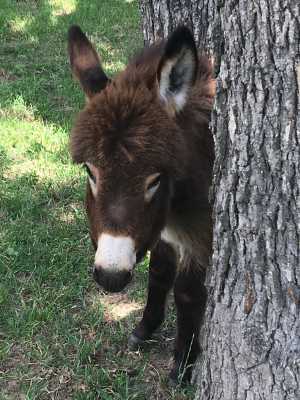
xmin=94 ymin=266 xmax=132 ymax=292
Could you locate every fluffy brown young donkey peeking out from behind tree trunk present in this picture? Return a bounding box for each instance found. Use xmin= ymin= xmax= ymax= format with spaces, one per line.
xmin=69 ymin=26 xmax=214 ymax=382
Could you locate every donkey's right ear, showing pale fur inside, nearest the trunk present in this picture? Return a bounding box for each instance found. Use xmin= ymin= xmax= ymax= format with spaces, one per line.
xmin=157 ymin=26 xmax=198 ymax=112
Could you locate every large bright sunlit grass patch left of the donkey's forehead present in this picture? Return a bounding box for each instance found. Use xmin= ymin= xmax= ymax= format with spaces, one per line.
xmin=0 ymin=101 xmax=74 ymax=184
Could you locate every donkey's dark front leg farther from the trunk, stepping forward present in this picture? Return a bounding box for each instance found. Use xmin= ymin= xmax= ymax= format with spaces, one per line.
xmin=128 ymin=240 xmax=176 ymax=350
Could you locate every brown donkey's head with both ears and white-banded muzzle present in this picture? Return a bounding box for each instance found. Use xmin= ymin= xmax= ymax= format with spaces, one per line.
xmin=69 ymin=26 xmax=198 ymax=291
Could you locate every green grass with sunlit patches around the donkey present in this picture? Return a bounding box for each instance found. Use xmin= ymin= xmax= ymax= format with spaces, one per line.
xmin=0 ymin=0 xmax=192 ymax=400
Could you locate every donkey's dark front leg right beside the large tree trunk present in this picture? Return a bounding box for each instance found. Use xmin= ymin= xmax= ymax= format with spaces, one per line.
xmin=170 ymin=263 xmax=207 ymax=385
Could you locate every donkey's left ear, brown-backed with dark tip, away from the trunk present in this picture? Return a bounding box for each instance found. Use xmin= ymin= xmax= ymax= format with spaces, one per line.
xmin=68 ymin=25 xmax=109 ymax=98
